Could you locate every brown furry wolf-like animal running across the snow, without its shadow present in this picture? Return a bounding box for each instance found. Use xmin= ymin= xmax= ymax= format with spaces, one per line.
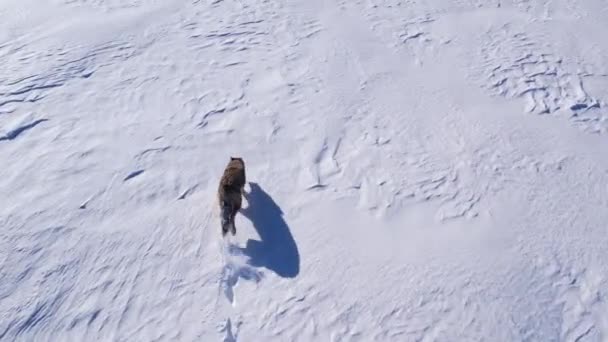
xmin=217 ymin=157 xmax=245 ymax=236
